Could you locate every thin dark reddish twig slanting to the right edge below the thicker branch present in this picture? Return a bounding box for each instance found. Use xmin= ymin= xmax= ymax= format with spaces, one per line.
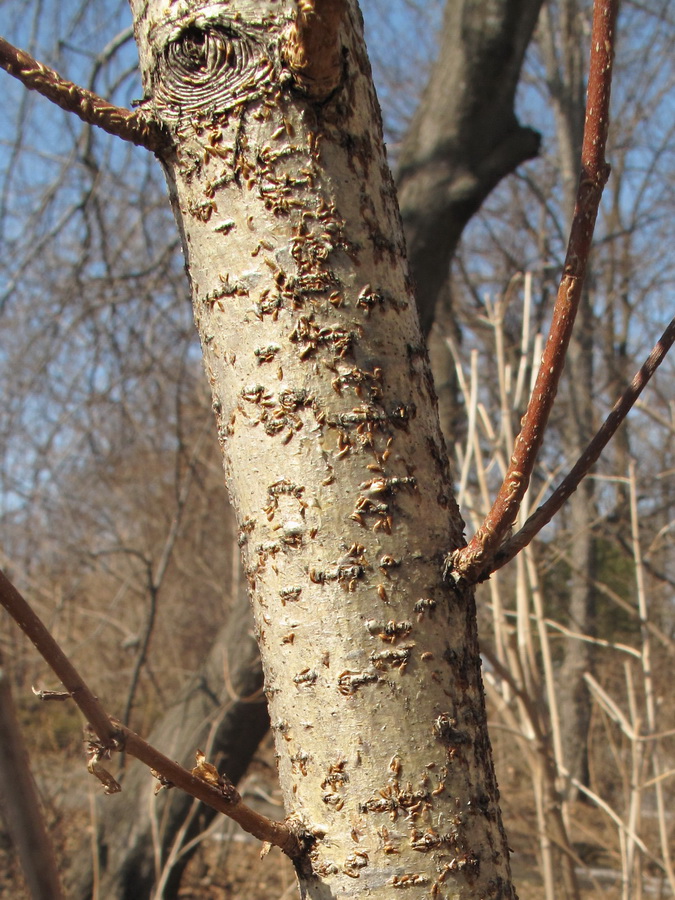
xmin=486 ymin=319 xmax=675 ymax=581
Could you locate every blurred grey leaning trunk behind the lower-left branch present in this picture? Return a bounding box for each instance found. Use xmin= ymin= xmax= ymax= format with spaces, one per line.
xmin=68 ymin=598 xmax=269 ymax=900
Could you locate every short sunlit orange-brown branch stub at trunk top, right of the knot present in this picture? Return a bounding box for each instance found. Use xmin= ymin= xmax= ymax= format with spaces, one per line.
xmin=284 ymin=0 xmax=345 ymax=100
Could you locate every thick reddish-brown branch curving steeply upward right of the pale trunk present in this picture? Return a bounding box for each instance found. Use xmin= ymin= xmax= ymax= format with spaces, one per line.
xmin=449 ymin=0 xmax=618 ymax=581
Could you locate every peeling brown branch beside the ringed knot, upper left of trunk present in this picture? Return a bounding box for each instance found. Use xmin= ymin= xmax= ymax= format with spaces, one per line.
xmin=0 ymin=37 xmax=167 ymax=152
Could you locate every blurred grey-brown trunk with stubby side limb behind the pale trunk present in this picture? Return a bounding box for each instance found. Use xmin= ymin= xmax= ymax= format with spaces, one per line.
xmin=397 ymin=0 xmax=542 ymax=334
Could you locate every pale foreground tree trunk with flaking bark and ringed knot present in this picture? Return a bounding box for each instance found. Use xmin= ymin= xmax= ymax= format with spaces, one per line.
xmin=132 ymin=0 xmax=515 ymax=900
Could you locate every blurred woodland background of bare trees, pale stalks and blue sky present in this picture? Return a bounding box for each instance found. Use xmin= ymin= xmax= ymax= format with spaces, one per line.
xmin=0 ymin=0 xmax=675 ymax=900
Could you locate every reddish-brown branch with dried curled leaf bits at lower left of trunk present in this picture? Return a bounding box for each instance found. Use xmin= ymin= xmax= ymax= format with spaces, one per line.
xmin=0 ymin=571 xmax=303 ymax=858
